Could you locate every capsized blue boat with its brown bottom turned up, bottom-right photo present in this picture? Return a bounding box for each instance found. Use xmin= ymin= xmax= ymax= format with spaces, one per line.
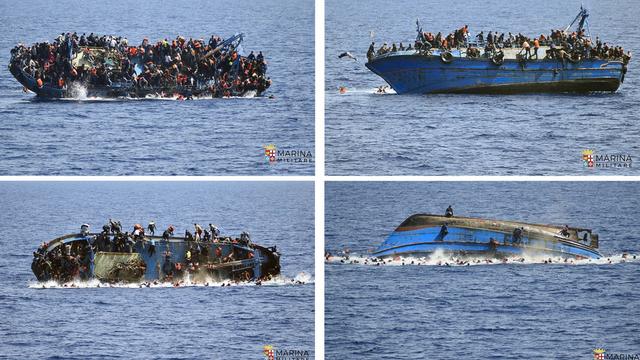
xmin=373 ymin=214 xmax=602 ymax=259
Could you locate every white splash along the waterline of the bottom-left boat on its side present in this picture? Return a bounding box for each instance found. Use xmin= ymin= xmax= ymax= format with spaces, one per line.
xmin=28 ymin=272 xmax=314 ymax=289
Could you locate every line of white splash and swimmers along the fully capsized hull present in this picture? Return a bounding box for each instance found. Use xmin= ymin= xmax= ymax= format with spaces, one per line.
xmin=325 ymin=253 xmax=640 ymax=266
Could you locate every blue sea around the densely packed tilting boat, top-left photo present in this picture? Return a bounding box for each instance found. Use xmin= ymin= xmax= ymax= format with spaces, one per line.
xmin=0 ymin=0 xmax=314 ymax=175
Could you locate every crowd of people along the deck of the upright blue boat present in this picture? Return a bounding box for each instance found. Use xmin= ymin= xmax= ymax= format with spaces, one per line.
xmin=367 ymin=25 xmax=631 ymax=63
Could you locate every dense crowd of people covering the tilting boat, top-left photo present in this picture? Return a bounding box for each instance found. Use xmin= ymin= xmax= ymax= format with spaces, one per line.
xmin=11 ymin=33 xmax=271 ymax=97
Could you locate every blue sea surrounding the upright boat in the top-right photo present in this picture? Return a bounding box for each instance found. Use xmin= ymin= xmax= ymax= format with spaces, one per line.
xmin=325 ymin=0 xmax=640 ymax=175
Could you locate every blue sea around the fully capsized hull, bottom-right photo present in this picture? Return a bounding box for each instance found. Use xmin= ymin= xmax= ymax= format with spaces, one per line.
xmin=325 ymin=182 xmax=640 ymax=359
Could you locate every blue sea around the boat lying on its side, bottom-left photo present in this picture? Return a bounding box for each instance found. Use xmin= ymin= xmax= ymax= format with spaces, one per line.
xmin=0 ymin=182 xmax=315 ymax=359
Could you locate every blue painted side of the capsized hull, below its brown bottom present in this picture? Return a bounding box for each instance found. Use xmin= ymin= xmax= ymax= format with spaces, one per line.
xmin=373 ymin=226 xmax=602 ymax=259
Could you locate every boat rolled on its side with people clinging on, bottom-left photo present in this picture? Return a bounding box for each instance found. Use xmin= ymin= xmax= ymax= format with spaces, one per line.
xmin=31 ymin=222 xmax=280 ymax=283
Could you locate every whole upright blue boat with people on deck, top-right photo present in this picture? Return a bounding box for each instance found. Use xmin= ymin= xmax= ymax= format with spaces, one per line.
xmin=365 ymin=8 xmax=631 ymax=94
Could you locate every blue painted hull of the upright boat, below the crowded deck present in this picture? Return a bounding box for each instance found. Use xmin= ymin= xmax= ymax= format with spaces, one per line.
xmin=366 ymin=51 xmax=625 ymax=94
